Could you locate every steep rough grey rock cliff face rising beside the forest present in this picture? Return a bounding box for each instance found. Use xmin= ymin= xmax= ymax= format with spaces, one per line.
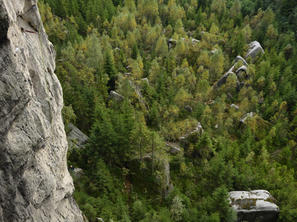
xmin=0 ymin=0 xmax=83 ymax=222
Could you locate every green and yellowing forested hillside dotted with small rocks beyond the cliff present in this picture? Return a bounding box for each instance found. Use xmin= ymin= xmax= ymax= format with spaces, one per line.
xmin=39 ymin=0 xmax=297 ymax=222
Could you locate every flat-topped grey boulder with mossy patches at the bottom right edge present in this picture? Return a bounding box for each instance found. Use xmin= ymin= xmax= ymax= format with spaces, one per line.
xmin=229 ymin=190 xmax=279 ymax=222
